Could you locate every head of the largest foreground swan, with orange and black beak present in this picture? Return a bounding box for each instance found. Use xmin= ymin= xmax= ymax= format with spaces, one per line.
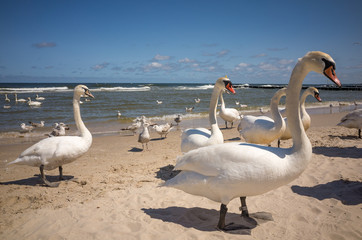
xmin=299 ymin=51 xmax=341 ymax=87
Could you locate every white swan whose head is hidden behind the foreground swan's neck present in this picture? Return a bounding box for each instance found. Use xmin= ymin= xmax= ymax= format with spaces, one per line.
xmin=238 ymin=88 xmax=287 ymax=146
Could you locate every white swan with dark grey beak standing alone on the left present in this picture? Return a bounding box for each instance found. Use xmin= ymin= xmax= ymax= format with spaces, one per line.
xmin=9 ymin=85 xmax=94 ymax=187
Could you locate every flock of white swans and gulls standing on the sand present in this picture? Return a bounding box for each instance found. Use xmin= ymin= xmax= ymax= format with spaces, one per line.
xmin=3 ymin=52 xmax=362 ymax=231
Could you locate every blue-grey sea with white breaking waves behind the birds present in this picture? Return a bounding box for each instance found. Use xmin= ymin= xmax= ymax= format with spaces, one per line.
xmin=0 ymin=83 xmax=362 ymax=138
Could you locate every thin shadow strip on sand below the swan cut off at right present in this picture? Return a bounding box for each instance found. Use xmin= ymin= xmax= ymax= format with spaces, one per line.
xmin=313 ymin=147 xmax=362 ymax=158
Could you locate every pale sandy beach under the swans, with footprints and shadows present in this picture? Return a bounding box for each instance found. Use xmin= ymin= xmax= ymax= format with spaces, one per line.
xmin=0 ymin=113 xmax=362 ymax=240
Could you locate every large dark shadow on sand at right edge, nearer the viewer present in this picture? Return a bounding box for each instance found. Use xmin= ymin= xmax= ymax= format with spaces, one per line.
xmin=291 ymin=179 xmax=362 ymax=205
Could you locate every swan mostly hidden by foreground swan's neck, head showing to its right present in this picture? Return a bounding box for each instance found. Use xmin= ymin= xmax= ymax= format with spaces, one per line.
xmin=278 ymin=87 xmax=322 ymax=147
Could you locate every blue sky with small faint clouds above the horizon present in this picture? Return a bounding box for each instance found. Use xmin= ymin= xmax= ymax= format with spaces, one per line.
xmin=0 ymin=0 xmax=362 ymax=84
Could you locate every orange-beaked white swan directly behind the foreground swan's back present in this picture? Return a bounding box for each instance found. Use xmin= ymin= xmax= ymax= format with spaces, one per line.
xmin=181 ymin=76 xmax=235 ymax=152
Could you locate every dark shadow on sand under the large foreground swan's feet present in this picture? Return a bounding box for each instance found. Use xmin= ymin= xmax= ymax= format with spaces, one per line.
xmin=142 ymin=207 xmax=273 ymax=235
